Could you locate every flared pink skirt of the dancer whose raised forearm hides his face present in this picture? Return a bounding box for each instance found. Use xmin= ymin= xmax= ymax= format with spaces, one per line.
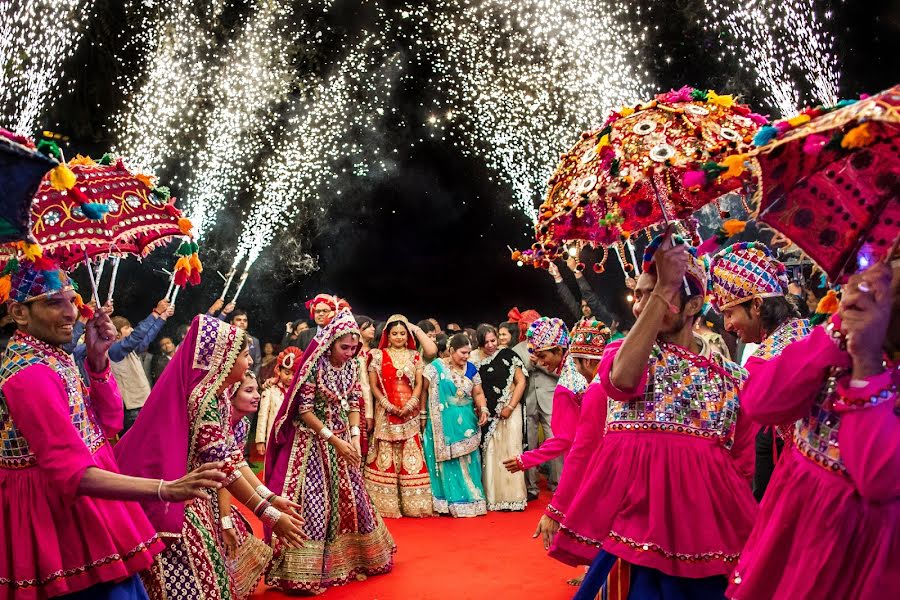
xmin=550 ymin=432 xmax=757 ymax=578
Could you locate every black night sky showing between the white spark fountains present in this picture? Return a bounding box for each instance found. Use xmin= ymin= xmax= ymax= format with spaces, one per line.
xmin=37 ymin=0 xmax=900 ymax=341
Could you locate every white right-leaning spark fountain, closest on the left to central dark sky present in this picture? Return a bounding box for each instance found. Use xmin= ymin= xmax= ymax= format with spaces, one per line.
xmin=234 ymin=34 xmax=401 ymax=268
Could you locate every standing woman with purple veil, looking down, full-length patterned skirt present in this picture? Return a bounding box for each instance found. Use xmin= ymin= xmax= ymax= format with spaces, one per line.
xmin=266 ymin=309 xmax=396 ymax=593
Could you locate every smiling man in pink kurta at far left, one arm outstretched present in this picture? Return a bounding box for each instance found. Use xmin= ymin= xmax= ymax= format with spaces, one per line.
xmin=0 ymin=257 xmax=224 ymax=600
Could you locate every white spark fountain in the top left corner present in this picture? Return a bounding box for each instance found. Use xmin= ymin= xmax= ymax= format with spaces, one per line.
xmin=0 ymin=0 xmax=94 ymax=135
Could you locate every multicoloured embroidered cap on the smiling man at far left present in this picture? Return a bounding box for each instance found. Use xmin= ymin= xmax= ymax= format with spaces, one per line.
xmin=0 ymin=242 xmax=93 ymax=318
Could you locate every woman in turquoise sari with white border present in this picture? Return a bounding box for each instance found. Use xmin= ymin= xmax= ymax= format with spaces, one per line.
xmin=422 ymin=333 xmax=488 ymax=517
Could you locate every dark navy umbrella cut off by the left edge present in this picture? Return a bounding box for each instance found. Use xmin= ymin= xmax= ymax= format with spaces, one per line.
xmin=0 ymin=129 xmax=57 ymax=243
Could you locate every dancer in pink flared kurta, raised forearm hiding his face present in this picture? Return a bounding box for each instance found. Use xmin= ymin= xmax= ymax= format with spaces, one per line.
xmin=557 ymin=231 xmax=756 ymax=600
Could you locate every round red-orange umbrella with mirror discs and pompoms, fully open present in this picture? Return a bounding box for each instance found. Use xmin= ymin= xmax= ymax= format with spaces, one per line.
xmin=513 ymin=87 xmax=766 ymax=271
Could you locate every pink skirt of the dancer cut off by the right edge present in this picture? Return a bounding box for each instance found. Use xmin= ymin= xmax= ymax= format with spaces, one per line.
xmin=727 ymin=447 xmax=900 ymax=600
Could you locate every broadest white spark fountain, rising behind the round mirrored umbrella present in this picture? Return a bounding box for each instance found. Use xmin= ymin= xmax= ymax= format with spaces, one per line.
xmin=407 ymin=0 xmax=651 ymax=219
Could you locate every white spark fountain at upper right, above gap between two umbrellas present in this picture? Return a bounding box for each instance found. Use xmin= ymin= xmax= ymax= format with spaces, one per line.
xmin=704 ymin=0 xmax=840 ymax=116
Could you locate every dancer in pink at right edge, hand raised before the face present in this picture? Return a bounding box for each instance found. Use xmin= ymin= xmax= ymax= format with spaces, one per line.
xmin=728 ymin=264 xmax=900 ymax=600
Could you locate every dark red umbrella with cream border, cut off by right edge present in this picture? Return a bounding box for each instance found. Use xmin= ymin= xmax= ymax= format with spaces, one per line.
xmin=736 ymin=85 xmax=900 ymax=282
